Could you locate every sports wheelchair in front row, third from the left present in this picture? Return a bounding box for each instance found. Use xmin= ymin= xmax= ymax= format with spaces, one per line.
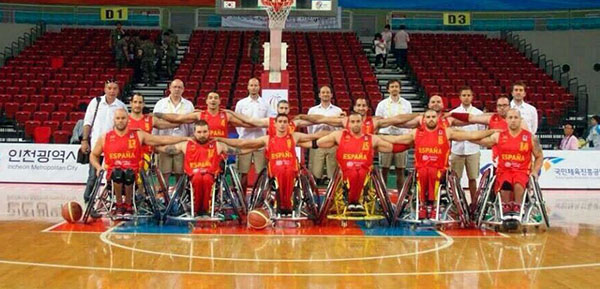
xmin=248 ymin=167 xmax=320 ymax=227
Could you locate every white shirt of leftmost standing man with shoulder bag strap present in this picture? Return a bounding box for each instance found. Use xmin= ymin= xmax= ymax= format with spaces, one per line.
xmin=83 ymin=95 xmax=127 ymax=149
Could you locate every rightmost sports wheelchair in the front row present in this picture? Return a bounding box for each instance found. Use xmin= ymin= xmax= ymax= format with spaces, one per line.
xmin=474 ymin=167 xmax=550 ymax=233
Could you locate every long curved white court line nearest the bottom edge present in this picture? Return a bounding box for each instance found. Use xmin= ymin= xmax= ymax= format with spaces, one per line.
xmin=0 ymin=260 xmax=600 ymax=277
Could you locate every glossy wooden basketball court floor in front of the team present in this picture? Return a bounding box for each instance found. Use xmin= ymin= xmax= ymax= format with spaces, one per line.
xmin=0 ymin=186 xmax=600 ymax=289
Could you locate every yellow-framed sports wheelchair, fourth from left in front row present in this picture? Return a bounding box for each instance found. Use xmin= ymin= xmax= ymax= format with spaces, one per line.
xmin=319 ymin=168 xmax=394 ymax=228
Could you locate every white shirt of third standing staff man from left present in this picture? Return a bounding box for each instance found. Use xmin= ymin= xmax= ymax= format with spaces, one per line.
xmin=235 ymin=96 xmax=269 ymax=139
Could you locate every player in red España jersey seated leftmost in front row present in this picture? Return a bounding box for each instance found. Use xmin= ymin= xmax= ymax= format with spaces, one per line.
xmin=90 ymin=109 xmax=187 ymax=215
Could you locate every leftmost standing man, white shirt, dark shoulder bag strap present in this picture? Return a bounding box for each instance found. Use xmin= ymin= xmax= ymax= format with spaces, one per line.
xmin=80 ymin=80 xmax=127 ymax=203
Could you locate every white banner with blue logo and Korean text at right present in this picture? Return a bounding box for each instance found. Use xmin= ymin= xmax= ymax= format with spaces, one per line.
xmin=461 ymin=150 xmax=600 ymax=190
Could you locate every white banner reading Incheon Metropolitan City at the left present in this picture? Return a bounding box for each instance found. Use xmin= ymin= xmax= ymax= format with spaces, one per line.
xmin=0 ymin=143 xmax=89 ymax=184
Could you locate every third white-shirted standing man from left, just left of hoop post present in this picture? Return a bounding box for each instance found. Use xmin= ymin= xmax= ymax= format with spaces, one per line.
xmin=235 ymin=78 xmax=269 ymax=192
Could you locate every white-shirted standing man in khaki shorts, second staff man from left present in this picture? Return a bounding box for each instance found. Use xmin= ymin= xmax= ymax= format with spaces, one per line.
xmin=154 ymin=79 xmax=194 ymax=186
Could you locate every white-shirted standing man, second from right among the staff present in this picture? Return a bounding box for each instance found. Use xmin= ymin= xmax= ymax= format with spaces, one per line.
xmin=450 ymin=87 xmax=485 ymax=201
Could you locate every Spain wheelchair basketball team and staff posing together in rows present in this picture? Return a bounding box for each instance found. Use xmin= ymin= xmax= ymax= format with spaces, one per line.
xmin=81 ymin=78 xmax=547 ymax=228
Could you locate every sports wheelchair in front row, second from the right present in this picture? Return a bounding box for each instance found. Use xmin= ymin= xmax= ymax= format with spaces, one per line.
xmin=394 ymin=169 xmax=471 ymax=229
